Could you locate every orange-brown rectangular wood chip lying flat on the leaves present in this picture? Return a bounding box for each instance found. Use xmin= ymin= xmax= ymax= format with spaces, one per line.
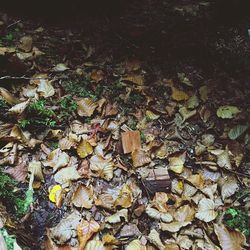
xmin=122 ymin=130 xmax=141 ymax=154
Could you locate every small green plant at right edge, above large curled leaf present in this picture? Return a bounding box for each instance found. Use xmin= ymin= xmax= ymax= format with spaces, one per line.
xmin=224 ymin=208 xmax=250 ymax=237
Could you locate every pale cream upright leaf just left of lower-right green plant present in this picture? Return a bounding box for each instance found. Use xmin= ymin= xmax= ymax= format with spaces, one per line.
xmin=195 ymin=198 xmax=217 ymax=222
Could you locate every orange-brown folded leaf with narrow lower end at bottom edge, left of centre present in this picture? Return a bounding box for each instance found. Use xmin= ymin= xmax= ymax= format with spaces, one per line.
xmin=77 ymin=219 xmax=100 ymax=249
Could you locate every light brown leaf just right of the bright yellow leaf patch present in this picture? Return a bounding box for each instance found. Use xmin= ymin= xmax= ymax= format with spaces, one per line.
xmin=72 ymin=185 xmax=94 ymax=209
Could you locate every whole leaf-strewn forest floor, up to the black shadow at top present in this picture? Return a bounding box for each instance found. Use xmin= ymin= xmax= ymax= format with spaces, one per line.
xmin=0 ymin=6 xmax=250 ymax=250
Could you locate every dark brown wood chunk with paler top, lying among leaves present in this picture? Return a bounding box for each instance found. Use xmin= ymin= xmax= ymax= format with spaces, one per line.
xmin=143 ymin=167 xmax=171 ymax=193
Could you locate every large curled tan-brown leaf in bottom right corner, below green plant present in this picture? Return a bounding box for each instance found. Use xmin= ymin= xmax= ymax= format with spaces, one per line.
xmin=214 ymin=224 xmax=246 ymax=250
